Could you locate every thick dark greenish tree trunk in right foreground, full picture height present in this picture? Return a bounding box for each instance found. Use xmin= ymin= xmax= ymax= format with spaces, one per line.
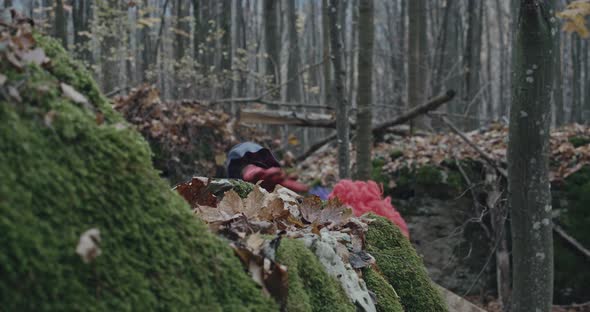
xmin=508 ymin=0 xmax=556 ymax=312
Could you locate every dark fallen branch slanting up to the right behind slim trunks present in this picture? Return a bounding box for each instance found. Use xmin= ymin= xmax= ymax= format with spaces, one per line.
xmin=296 ymin=90 xmax=455 ymax=162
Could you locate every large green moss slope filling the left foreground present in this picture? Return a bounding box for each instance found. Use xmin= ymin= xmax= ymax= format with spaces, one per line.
xmin=0 ymin=36 xmax=278 ymax=311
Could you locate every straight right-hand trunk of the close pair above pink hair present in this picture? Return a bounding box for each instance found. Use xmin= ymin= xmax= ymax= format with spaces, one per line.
xmin=356 ymin=0 xmax=375 ymax=180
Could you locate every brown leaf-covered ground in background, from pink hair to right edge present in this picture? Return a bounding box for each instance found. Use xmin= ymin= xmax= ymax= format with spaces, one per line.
xmin=298 ymin=124 xmax=590 ymax=188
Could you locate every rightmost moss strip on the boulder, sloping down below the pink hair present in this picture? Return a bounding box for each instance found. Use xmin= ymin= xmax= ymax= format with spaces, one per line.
xmin=366 ymin=215 xmax=447 ymax=312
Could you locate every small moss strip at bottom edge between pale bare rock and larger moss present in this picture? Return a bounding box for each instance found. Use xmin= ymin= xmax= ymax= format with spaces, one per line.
xmin=363 ymin=268 xmax=404 ymax=312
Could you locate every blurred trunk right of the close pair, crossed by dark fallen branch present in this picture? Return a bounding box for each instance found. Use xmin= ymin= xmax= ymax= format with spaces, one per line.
xmin=408 ymin=0 xmax=430 ymax=131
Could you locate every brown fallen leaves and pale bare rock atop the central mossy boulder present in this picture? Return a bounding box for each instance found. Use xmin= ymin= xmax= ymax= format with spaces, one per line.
xmin=174 ymin=177 xmax=382 ymax=311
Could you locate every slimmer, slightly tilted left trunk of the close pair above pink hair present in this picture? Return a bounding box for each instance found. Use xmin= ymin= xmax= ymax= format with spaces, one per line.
xmin=328 ymin=0 xmax=350 ymax=179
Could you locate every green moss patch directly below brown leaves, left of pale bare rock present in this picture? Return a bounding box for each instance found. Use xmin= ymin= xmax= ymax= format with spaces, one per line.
xmin=277 ymin=239 xmax=355 ymax=312
